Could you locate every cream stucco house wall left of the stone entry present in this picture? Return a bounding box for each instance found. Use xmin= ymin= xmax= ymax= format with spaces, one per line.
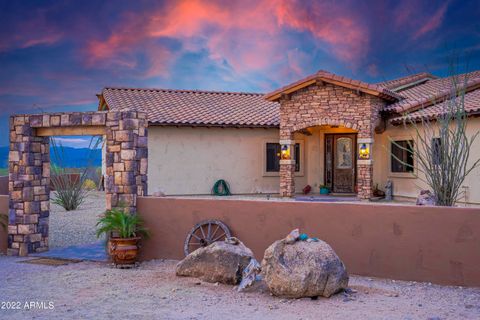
xmin=148 ymin=126 xmax=307 ymax=195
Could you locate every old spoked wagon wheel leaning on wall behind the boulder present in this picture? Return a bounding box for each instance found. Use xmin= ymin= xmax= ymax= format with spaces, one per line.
xmin=183 ymin=220 xmax=231 ymax=256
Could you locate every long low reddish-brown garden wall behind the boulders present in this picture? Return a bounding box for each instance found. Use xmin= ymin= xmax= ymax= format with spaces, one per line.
xmin=137 ymin=197 xmax=480 ymax=286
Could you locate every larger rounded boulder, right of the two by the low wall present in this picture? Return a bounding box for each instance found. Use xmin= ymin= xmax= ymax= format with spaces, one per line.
xmin=262 ymin=239 xmax=348 ymax=298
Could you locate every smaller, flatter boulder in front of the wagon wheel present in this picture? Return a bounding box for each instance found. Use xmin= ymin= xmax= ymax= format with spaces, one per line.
xmin=176 ymin=241 xmax=253 ymax=284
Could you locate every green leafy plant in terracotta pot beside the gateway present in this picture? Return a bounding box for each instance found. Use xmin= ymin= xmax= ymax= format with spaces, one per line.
xmin=97 ymin=208 xmax=149 ymax=266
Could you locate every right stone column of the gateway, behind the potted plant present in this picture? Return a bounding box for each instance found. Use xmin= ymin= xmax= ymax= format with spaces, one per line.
xmin=105 ymin=112 xmax=148 ymax=213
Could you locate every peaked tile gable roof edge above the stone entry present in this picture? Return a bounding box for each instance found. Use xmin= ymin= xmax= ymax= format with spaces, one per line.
xmin=265 ymin=70 xmax=402 ymax=101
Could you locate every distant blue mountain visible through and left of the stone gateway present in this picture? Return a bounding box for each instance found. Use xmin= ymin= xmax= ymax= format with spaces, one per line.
xmin=0 ymin=147 xmax=102 ymax=168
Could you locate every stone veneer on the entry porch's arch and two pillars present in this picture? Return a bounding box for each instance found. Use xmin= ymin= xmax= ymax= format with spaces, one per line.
xmin=279 ymin=83 xmax=385 ymax=199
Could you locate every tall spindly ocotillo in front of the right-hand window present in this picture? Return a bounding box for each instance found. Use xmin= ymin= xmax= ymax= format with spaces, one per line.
xmin=389 ymin=68 xmax=480 ymax=206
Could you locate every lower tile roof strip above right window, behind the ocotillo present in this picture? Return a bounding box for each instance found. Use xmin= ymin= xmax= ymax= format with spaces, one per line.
xmin=390 ymin=89 xmax=480 ymax=124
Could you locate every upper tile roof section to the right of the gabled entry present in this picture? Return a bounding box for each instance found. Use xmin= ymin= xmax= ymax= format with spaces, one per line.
xmin=385 ymin=71 xmax=480 ymax=113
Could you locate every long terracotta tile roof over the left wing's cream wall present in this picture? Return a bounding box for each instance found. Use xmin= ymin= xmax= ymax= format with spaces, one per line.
xmin=102 ymin=88 xmax=280 ymax=127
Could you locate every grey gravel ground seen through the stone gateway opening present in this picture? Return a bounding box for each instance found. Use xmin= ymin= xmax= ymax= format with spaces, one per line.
xmin=48 ymin=191 xmax=105 ymax=248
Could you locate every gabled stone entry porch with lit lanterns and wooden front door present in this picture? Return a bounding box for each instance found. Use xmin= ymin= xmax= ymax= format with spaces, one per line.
xmin=266 ymin=70 xmax=398 ymax=200
